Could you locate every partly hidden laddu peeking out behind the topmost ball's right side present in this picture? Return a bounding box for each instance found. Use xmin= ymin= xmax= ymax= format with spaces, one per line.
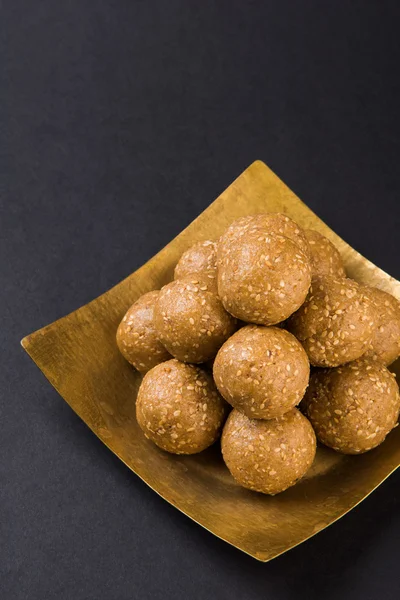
xmin=304 ymin=229 xmax=346 ymax=278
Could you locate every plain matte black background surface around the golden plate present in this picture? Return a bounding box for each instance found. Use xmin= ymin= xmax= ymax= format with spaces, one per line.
xmin=0 ymin=0 xmax=400 ymax=600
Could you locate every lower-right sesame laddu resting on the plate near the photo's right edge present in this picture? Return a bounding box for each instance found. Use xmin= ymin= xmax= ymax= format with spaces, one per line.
xmin=302 ymin=358 xmax=400 ymax=454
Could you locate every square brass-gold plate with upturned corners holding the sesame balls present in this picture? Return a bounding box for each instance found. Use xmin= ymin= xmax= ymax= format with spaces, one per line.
xmin=22 ymin=161 xmax=400 ymax=561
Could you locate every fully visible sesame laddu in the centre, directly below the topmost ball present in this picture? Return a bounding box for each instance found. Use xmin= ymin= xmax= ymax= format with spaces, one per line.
xmin=213 ymin=325 xmax=310 ymax=419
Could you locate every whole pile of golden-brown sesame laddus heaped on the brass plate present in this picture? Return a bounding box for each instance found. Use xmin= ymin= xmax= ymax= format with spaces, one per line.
xmin=117 ymin=213 xmax=400 ymax=495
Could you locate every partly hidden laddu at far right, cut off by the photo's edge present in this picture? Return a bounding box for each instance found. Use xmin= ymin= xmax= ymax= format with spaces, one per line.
xmin=364 ymin=286 xmax=400 ymax=365
